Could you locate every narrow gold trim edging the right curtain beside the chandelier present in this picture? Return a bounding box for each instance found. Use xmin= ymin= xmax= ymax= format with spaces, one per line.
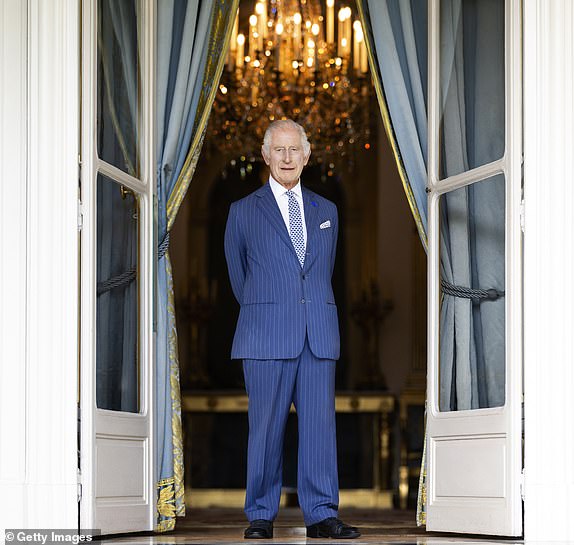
xmin=357 ymin=0 xmax=428 ymax=253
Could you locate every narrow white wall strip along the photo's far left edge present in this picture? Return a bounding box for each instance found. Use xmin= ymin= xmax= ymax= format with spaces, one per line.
xmin=0 ymin=0 xmax=27 ymax=526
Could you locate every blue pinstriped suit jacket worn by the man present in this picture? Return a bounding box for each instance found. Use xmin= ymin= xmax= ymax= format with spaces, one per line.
xmin=225 ymin=183 xmax=340 ymax=360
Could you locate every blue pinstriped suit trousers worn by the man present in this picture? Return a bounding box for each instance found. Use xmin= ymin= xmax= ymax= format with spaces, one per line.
xmin=243 ymin=339 xmax=339 ymax=526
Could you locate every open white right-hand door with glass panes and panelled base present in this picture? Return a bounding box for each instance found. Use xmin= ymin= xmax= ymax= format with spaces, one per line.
xmin=427 ymin=0 xmax=522 ymax=536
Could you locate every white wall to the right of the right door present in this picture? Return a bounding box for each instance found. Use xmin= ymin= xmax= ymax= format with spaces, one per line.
xmin=524 ymin=0 xmax=574 ymax=542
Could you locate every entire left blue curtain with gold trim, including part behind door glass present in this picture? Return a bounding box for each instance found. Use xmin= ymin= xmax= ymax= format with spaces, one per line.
xmin=97 ymin=0 xmax=239 ymax=531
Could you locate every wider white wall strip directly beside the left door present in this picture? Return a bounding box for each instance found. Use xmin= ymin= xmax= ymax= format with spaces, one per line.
xmin=26 ymin=0 xmax=79 ymax=527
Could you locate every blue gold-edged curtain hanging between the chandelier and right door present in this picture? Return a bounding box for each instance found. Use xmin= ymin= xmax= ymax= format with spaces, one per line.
xmin=357 ymin=0 xmax=428 ymax=248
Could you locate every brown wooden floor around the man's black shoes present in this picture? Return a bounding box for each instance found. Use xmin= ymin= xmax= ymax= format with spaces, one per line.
xmin=101 ymin=508 xmax=523 ymax=545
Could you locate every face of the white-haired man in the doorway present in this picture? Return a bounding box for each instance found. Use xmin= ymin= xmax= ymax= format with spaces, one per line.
xmin=261 ymin=127 xmax=311 ymax=189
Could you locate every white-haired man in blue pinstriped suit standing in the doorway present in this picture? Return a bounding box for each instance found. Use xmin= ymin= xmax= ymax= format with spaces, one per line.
xmin=225 ymin=120 xmax=360 ymax=538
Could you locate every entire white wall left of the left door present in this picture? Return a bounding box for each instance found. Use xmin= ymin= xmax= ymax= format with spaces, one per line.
xmin=0 ymin=0 xmax=79 ymax=528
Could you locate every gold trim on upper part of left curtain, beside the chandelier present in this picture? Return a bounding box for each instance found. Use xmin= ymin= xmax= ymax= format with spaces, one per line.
xmin=167 ymin=0 xmax=239 ymax=227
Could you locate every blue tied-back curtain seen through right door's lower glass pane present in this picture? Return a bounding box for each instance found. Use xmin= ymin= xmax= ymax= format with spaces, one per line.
xmin=439 ymin=174 xmax=505 ymax=411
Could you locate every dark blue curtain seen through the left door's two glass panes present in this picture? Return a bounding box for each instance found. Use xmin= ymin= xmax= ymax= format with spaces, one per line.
xmin=96 ymin=0 xmax=140 ymax=412
